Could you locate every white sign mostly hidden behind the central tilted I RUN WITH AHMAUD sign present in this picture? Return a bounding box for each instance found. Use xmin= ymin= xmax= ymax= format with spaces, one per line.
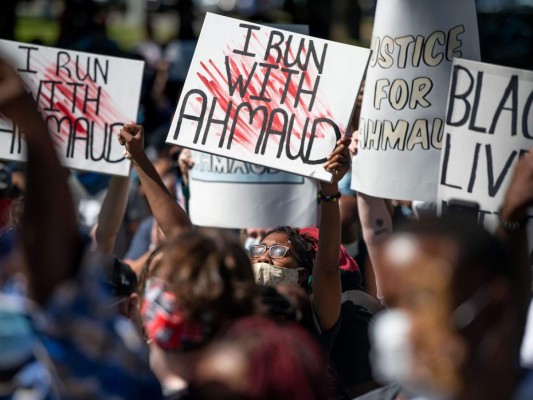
xmin=189 ymin=151 xmax=317 ymax=228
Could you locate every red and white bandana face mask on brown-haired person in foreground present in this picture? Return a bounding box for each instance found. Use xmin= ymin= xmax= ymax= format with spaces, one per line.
xmin=141 ymin=278 xmax=210 ymax=351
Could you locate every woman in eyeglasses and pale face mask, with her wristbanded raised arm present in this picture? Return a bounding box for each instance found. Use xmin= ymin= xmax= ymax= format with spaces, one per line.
xmin=249 ymin=138 xmax=350 ymax=354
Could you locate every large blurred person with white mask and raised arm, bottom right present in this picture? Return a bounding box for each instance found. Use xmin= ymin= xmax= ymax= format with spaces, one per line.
xmin=361 ymin=146 xmax=533 ymax=400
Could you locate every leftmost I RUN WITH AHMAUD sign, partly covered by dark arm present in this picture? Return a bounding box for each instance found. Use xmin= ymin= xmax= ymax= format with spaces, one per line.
xmin=0 ymin=40 xmax=144 ymax=176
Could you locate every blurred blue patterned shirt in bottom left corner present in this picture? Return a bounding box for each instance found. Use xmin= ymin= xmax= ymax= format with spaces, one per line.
xmin=0 ymin=252 xmax=163 ymax=400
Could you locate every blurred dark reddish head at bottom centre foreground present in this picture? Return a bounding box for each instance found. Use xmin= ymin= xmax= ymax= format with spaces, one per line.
xmin=187 ymin=317 xmax=332 ymax=400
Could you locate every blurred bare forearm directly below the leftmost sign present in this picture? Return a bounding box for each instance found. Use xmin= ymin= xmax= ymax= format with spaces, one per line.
xmin=93 ymin=176 xmax=130 ymax=254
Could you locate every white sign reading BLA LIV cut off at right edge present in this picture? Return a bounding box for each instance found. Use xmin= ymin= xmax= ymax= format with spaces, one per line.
xmin=438 ymin=59 xmax=533 ymax=230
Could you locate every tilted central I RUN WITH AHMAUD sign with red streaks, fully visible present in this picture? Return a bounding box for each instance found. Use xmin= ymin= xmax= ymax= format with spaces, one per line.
xmin=167 ymin=14 xmax=369 ymax=181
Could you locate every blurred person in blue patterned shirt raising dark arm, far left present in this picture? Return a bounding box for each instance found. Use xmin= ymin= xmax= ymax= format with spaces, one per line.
xmin=0 ymin=57 xmax=161 ymax=399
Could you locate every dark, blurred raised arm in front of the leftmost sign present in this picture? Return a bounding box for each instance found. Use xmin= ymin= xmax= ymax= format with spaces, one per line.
xmin=0 ymin=61 xmax=82 ymax=303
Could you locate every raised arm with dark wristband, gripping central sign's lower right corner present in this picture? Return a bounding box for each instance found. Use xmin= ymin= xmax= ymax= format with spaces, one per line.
xmin=312 ymin=138 xmax=350 ymax=330
